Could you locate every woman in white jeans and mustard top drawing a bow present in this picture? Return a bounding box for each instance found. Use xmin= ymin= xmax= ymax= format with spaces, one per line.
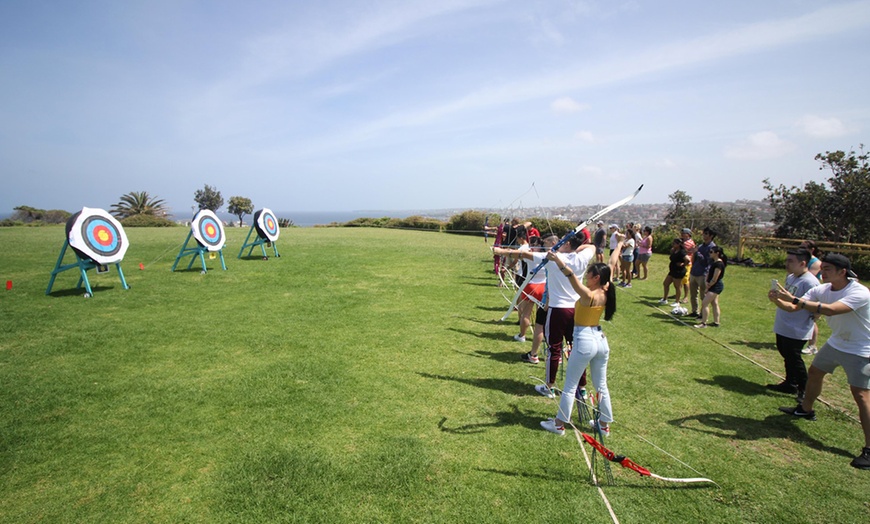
xmin=541 ymin=239 xmax=624 ymax=436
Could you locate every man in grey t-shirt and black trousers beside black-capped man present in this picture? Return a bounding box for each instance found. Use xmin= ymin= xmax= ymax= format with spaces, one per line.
xmin=765 ymin=248 xmax=819 ymax=398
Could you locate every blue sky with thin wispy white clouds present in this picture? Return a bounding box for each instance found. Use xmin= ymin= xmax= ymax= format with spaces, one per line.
xmin=0 ymin=0 xmax=870 ymax=213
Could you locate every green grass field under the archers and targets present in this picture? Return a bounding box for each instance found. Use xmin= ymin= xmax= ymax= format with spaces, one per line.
xmin=0 ymin=227 xmax=870 ymax=524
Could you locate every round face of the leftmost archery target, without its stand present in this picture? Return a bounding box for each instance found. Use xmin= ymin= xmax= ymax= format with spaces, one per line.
xmin=66 ymin=207 xmax=129 ymax=264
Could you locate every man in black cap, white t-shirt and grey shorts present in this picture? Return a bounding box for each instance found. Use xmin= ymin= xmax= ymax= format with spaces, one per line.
xmin=776 ymin=253 xmax=870 ymax=470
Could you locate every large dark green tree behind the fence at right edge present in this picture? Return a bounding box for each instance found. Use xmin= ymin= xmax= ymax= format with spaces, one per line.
xmin=764 ymin=144 xmax=870 ymax=243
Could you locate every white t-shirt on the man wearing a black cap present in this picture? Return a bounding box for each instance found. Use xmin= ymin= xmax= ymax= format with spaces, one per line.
xmin=801 ymin=280 xmax=870 ymax=357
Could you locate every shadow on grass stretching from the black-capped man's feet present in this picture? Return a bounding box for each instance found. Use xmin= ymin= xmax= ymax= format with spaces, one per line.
xmin=668 ymin=413 xmax=853 ymax=459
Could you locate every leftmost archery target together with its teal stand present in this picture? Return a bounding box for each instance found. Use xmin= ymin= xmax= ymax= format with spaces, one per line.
xmin=45 ymin=207 xmax=130 ymax=298
